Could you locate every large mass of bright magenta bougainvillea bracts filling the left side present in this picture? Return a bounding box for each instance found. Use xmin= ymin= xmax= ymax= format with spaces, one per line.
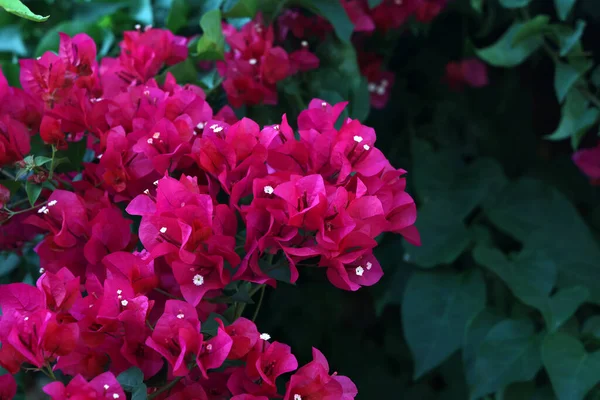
xmin=0 ymin=10 xmax=419 ymax=400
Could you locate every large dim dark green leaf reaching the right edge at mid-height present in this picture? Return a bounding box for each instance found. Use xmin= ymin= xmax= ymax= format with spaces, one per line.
xmin=485 ymin=178 xmax=600 ymax=303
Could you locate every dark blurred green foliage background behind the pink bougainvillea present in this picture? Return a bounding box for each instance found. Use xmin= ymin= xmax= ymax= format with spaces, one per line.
xmin=0 ymin=0 xmax=600 ymax=400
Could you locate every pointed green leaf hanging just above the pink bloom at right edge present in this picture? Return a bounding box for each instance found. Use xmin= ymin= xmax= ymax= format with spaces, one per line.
xmin=546 ymin=90 xmax=599 ymax=140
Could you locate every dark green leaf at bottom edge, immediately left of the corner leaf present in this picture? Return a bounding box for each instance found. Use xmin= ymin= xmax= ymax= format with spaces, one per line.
xmin=471 ymin=320 xmax=541 ymax=399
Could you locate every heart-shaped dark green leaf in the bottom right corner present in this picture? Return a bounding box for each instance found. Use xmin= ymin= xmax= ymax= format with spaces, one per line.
xmin=542 ymin=333 xmax=600 ymax=400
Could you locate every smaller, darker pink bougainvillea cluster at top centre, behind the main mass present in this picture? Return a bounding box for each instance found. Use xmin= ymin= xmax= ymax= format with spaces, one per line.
xmin=217 ymin=15 xmax=319 ymax=107
